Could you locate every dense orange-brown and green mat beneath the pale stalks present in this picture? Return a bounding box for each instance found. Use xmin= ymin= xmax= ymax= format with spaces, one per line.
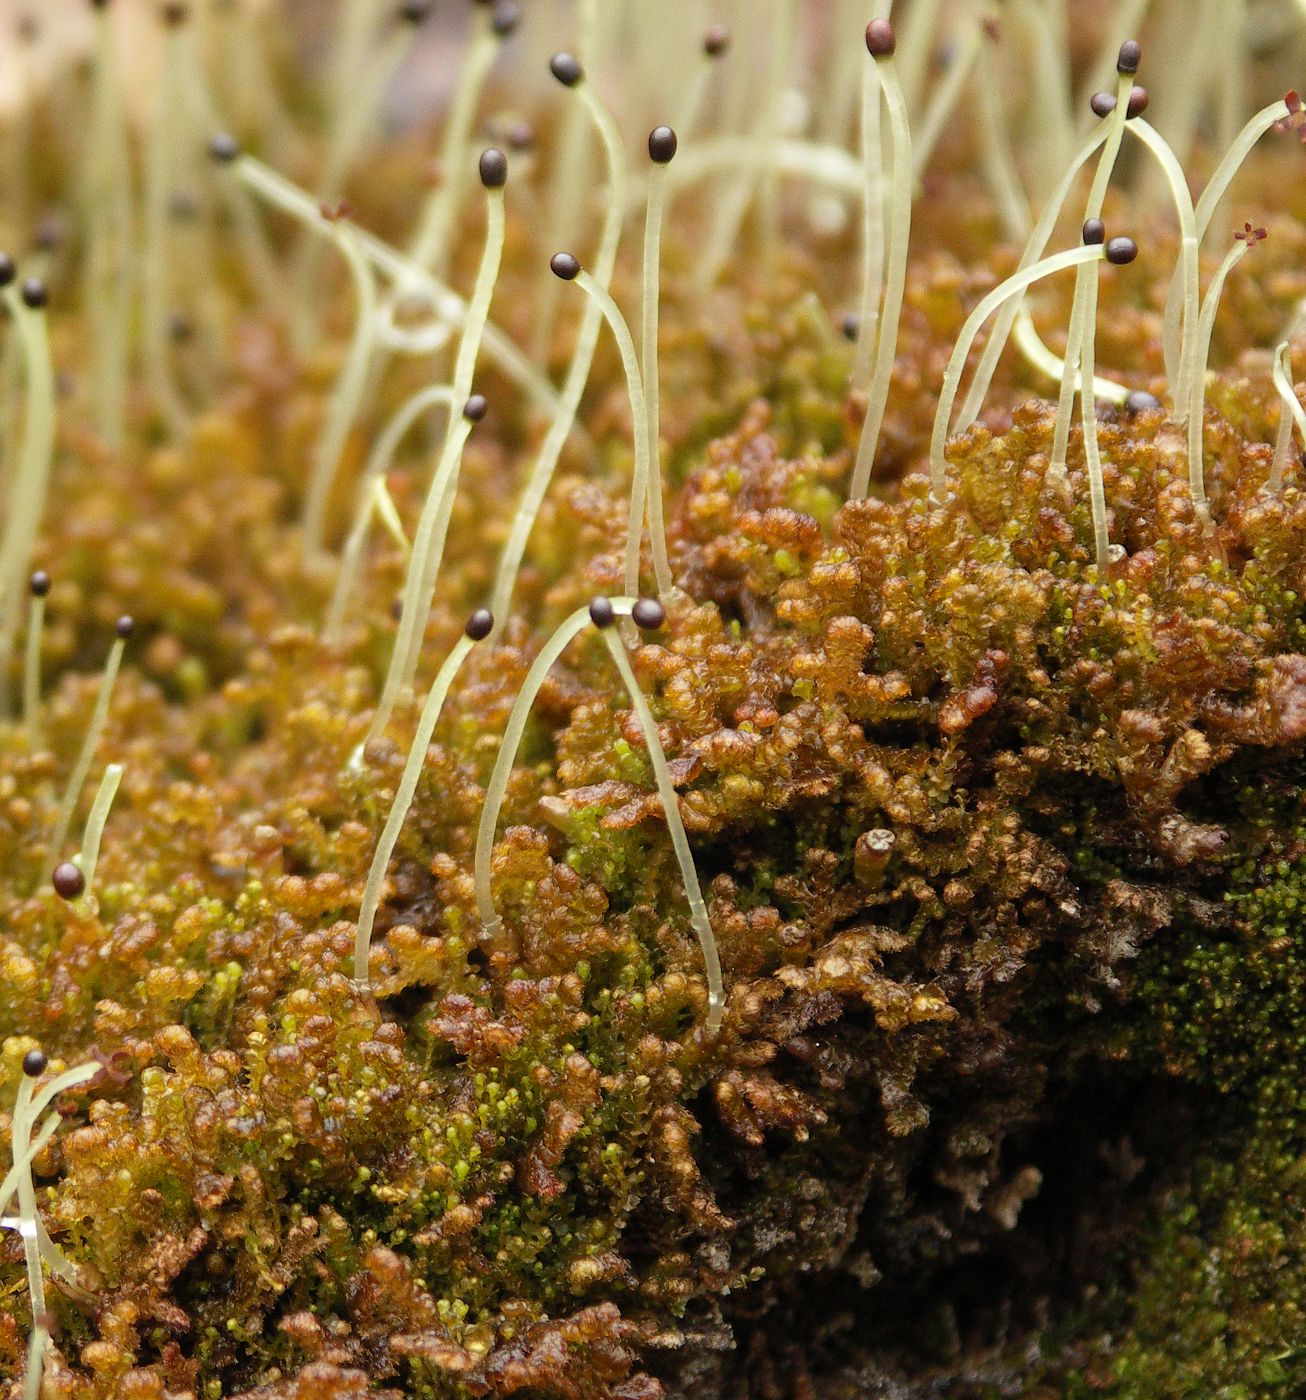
xmin=0 ymin=5 xmax=1306 ymax=1400
